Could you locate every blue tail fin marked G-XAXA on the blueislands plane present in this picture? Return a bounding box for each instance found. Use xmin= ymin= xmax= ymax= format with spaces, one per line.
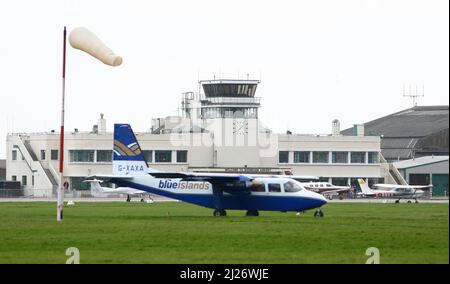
xmin=113 ymin=124 xmax=148 ymax=175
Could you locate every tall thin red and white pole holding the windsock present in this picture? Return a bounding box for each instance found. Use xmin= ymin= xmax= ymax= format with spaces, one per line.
xmin=56 ymin=27 xmax=67 ymax=222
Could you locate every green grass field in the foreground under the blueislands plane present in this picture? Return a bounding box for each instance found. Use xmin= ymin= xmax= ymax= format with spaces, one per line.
xmin=0 ymin=202 xmax=449 ymax=263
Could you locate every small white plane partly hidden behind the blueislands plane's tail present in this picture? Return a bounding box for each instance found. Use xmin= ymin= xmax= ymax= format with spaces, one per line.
xmin=83 ymin=179 xmax=153 ymax=203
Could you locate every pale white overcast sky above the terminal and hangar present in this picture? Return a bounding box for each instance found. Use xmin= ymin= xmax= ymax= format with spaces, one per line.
xmin=0 ymin=0 xmax=449 ymax=159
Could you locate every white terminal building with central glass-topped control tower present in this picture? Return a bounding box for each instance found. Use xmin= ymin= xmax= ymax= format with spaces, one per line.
xmin=6 ymin=80 xmax=412 ymax=196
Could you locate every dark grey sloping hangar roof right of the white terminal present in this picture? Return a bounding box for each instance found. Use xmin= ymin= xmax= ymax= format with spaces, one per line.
xmin=341 ymin=106 xmax=449 ymax=138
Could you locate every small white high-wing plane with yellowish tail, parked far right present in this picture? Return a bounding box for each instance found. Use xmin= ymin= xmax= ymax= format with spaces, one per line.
xmin=357 ymin=179 xmax=424 ymax=203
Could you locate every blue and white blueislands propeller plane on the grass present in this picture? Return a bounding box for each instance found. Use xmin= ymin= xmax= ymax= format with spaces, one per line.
xmin=88 ymin=124 xmax=327 ymax=217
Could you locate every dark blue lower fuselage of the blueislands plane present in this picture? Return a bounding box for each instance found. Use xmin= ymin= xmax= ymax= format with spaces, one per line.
xmin=111 ymin=179 xmax=324 ymax=211
